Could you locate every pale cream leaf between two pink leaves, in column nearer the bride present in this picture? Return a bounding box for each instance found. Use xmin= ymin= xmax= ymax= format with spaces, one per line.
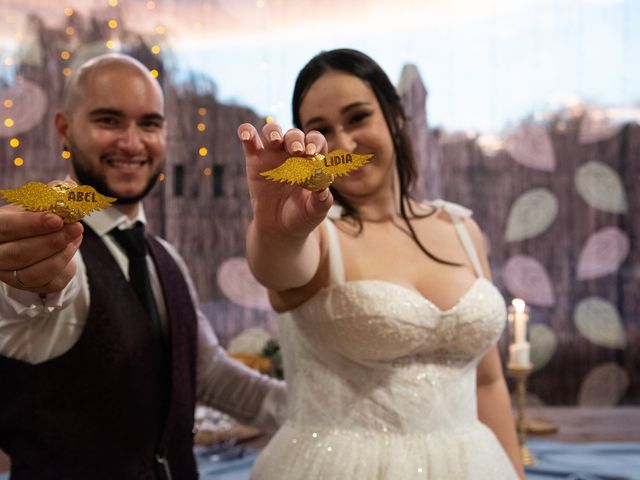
xmin=505 ymin=188 xmax=558 ymax=242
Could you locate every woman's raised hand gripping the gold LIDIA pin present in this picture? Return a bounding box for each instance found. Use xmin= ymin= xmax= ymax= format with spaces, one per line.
xmin=238 ymin=123 xmax=333 ymax=240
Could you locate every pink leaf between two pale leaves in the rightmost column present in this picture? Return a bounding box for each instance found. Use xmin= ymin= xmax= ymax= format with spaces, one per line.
xmin=576 ymin=227 xmax=630 ymax=280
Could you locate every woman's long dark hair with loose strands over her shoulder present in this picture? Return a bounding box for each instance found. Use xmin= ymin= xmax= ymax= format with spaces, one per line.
xmin=292 ymin=48 xmax=459 ymax=265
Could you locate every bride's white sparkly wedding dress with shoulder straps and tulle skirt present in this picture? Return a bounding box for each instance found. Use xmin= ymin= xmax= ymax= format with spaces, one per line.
xmin=252 ymin=202 xmax=518 ymax=480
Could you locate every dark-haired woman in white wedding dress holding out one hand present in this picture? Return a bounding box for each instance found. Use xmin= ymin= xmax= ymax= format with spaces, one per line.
xmin=238 ymin=49 xmax=524 ymax=480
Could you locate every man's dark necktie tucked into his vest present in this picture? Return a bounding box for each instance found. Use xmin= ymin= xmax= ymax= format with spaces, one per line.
xmin=110 ymin=222 xmax=162 ymax=334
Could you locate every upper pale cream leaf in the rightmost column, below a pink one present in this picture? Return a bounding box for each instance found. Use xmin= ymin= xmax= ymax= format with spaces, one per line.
xmin=574 ymin=161 xmax=628 ymax=213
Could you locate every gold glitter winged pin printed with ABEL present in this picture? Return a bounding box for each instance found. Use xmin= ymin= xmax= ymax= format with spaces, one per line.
xmin=0 ymin=182 xmax=116 ymax=223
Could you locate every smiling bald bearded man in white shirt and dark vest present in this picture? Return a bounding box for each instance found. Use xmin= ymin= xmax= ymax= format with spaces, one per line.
xmin=0 ymin=55 xmax=284 ymax=480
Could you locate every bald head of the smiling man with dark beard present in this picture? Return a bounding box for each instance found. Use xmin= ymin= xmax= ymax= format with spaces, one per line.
xmin=55 ymin=54 xmax=166 ymax=210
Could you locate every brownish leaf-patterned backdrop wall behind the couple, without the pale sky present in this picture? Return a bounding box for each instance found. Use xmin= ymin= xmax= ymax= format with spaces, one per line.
xmin=0 ymin=10 xmax=640 ymax=406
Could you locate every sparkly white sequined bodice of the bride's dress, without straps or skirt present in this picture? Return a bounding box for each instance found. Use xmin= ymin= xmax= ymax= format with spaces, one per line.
xmin=280 ymin=278 xmax=505 ymax=433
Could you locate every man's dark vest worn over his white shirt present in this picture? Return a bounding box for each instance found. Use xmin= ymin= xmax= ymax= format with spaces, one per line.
xmin=0 ymin=225 xmax=197 ymax=480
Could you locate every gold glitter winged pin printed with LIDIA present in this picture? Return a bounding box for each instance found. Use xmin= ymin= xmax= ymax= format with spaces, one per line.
xmin=260 ymin=150 xmax=373 ymax=190
